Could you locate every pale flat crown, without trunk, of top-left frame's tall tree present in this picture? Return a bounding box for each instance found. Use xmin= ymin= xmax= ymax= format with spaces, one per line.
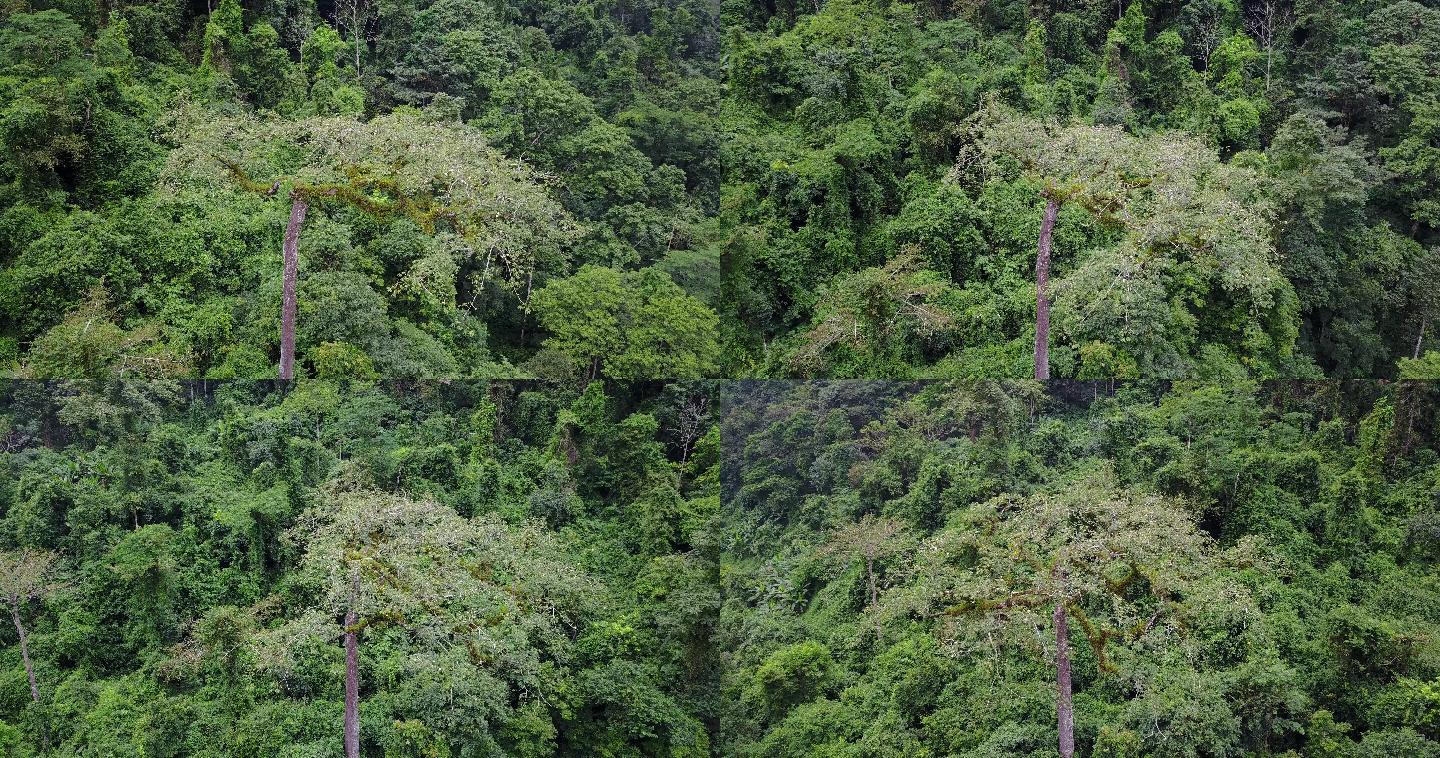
xmin=161 ymin=108 xmax=580 ymax=291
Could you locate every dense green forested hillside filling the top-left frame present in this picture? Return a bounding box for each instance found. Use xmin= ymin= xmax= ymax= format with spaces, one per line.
xmin=0 ymin=0 xmax=720 ymax=379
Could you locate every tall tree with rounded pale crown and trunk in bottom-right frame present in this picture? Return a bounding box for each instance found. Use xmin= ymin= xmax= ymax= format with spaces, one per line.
xmin=919 ymin=470 xmax=1238 ymax=758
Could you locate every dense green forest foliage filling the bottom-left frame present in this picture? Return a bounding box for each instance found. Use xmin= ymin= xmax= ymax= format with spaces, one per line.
xmin=0 ymin=380 xmax=720 ymax=757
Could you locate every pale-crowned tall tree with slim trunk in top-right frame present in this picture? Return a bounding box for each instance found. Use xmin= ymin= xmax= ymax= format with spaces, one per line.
xmin=978 ymin=108 xmax=1295 ymax=379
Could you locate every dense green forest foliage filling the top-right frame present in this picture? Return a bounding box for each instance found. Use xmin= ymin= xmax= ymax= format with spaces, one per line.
xmin=721 ymin=0 xmax=1440 ymax=378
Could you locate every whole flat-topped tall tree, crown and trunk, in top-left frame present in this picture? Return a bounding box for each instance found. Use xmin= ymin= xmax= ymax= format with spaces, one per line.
xmin=164 ymin=106 xmax=577 ymax=379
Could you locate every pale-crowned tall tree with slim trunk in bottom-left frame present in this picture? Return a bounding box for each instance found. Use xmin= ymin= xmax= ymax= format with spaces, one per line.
xmin=276 ymin=483 xmax=600 ymax=758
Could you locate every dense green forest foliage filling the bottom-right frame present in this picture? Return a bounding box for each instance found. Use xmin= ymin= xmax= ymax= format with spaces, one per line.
xmin=716 ymin=380 xmax=1440 ymax=758
